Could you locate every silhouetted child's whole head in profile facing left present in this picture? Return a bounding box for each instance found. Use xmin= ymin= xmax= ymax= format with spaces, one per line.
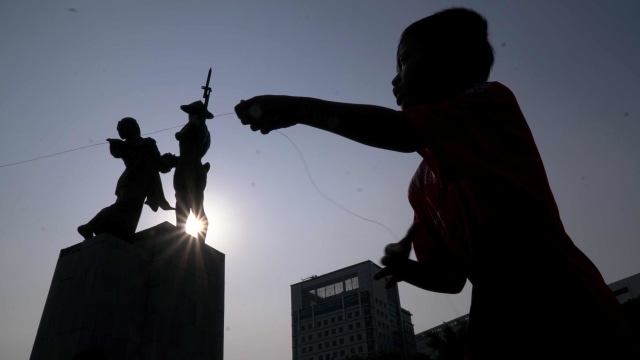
xmin=393 ymin=8 xmax=494 ymax=108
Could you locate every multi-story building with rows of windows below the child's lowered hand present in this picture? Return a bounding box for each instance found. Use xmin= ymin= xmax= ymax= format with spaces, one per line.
xmin=291 ymin=261 xmax=416 ymax=360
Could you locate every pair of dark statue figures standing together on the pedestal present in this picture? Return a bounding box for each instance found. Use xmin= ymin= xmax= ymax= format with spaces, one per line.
xmin=78 ymin=101 xmax=213 ymax=242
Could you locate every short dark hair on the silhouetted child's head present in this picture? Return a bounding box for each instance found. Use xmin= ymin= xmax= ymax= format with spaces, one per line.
xmin=400 ymin=7 xmax=494 ymax=83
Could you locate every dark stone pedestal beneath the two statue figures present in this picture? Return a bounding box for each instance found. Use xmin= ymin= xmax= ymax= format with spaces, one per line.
xmin=30 ymin=222 xmax=225 ymax=360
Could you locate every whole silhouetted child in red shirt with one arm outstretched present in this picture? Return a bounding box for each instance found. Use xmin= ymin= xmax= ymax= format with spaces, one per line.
xmin=236 ymin=8 xmax=640 ymax=359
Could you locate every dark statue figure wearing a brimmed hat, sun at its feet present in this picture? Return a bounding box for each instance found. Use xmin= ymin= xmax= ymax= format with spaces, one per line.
xmin=163 ymin=101 xmax=213 ymax=242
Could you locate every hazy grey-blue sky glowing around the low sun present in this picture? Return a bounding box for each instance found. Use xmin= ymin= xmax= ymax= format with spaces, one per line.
xmin=0 ymin=0 xmax=640 ymax=360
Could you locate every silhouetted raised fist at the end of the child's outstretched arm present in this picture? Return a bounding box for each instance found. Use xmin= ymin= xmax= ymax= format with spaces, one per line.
xmin=235 ymin=95 xmax=303 ymax=134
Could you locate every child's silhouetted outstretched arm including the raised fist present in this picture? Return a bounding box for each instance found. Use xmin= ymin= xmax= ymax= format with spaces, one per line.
xmin=235 ymin=95 xmax=421 ymax=152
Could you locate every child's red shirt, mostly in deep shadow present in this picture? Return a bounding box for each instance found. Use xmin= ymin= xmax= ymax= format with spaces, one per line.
xmin=405 ymin=82 xmax=626 ymax=358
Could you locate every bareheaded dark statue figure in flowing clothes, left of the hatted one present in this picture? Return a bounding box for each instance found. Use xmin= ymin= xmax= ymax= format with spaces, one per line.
xmin=78 ymin=117 xmax=174 ymax=242
